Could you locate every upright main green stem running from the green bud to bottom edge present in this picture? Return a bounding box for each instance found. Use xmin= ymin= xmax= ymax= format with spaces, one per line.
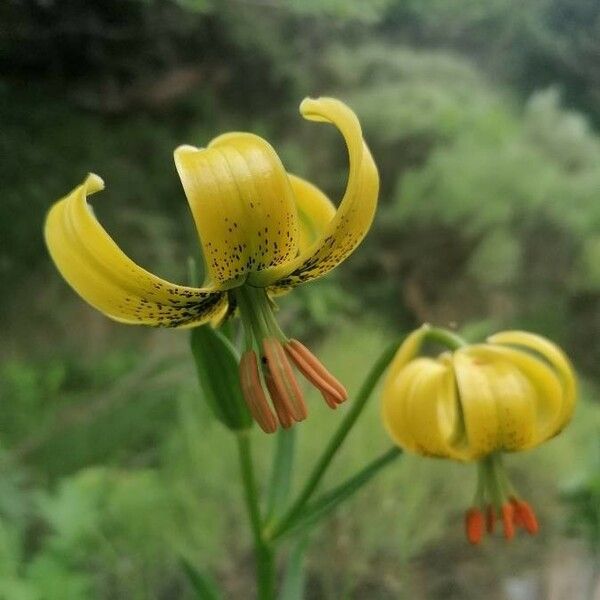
xmin=236 ymin=431 xmax=275 ymax=600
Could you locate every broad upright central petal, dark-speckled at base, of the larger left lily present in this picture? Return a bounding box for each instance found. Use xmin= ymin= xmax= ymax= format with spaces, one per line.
xmin=175 ymin=133 xmax=298 ymax=289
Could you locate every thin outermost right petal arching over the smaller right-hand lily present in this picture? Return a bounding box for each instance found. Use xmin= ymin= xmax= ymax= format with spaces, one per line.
xmin=488 ymin=331 xmax=577 ymax=434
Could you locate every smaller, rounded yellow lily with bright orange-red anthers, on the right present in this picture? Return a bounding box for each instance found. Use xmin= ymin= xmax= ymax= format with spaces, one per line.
xmin=382 ymin=325 xmax=576 ymax=543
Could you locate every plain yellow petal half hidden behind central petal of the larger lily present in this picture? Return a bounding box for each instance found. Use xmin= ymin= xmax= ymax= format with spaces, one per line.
xmin=288 ymin=173 xmax=335 ymax=253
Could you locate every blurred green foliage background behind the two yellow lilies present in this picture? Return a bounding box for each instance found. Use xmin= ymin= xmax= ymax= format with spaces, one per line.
xmin=0 ymin=0 xmax=600 ymax=600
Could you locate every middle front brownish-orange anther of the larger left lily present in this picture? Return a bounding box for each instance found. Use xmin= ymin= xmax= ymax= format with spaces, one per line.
xmin=263 ymin=338 xmax=307 ymax=425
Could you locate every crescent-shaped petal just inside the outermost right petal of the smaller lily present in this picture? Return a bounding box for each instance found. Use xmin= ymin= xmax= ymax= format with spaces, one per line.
xmin=486 ymin=345 xmax=564 ymax=447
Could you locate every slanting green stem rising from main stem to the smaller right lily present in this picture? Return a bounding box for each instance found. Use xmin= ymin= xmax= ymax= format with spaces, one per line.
xmin=266 ymin=342 xmax=399 ymax=539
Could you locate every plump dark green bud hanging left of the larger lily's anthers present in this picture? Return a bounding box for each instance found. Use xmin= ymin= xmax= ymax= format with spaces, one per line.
xmin=190 ymin=325 xmax=252 ymax=431
